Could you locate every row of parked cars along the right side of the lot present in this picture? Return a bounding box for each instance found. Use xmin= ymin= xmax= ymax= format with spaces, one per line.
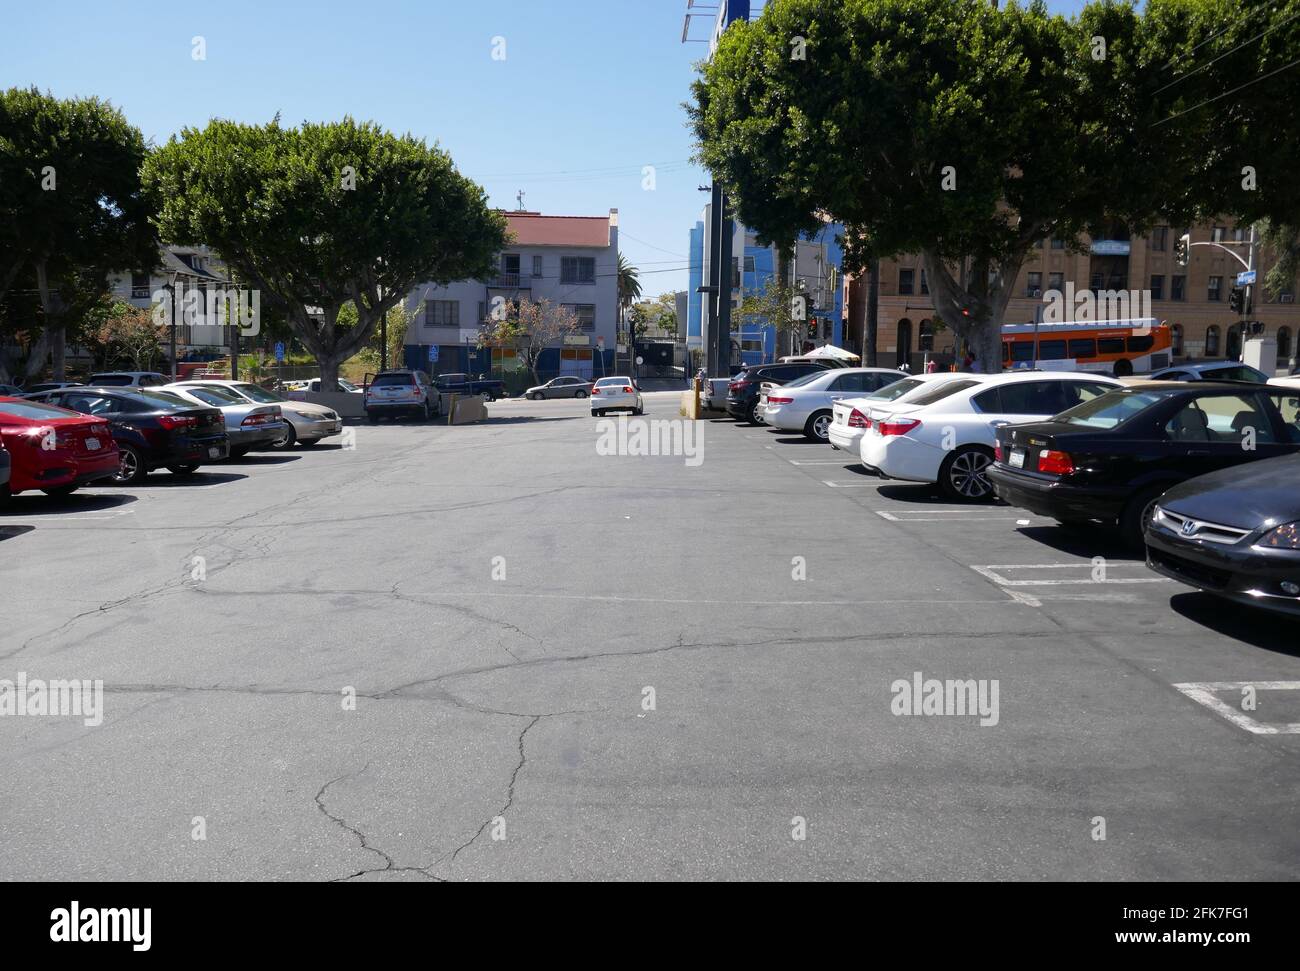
xmin=728 ymin=363 xmax=1300 ymax=616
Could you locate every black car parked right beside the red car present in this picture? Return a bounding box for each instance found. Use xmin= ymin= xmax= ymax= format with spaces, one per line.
xmin=33 ymin=387 xmax=230 ymax=485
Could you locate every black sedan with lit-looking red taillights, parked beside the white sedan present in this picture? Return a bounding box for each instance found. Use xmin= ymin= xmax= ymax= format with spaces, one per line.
xmin=988 ymin=381 xmax=1300 ymax=549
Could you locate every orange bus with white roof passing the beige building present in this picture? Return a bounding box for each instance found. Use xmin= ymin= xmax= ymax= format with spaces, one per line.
xmin=1002 ymin=317 xmax=1174 ymax=377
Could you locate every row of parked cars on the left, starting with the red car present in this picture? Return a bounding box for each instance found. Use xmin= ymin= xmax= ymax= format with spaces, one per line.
xmin=0 ymin=381 xmax=343 ymax=500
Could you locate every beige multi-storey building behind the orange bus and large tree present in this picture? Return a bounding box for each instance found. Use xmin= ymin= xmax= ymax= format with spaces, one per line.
xmin=845 ymin=221 xmax=1300 ymax=368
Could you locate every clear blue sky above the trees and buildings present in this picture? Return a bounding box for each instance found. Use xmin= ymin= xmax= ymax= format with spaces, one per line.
xmin=0 ymin=0 xmax=1080 ymax=295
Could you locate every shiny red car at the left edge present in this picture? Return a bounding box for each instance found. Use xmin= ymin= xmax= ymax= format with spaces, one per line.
xmin=0 ymin=398 xmax=121 ymax=498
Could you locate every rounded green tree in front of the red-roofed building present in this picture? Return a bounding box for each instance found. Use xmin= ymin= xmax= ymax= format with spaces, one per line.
xmin=144 ymin=118 xmax=507 ymax=390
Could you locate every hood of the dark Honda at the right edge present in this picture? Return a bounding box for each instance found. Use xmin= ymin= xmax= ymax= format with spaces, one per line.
xmin=1160 ymin=455 xmax=1300 ymax=529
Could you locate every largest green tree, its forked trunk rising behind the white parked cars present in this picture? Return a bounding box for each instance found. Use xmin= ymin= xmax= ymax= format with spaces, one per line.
xmin=688 ymin=0 xmax=1206 ymax=370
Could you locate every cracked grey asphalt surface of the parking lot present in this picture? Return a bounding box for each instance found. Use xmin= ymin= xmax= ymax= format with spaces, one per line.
xmin=0 ymin=394 xmax=1300 ymax=880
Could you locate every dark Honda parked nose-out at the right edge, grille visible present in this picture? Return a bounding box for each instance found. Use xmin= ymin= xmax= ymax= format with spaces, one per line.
xmin=1147 ymin=455 xmax=1300 ymax=616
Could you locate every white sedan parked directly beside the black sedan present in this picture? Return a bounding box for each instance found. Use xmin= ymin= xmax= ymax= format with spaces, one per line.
xmin=861 ymin=370 xmax=1123 ymax=502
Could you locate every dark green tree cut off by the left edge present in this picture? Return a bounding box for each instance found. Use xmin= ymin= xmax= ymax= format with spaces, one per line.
xmin=0 ymin=87 xmax=157 ymax=380
